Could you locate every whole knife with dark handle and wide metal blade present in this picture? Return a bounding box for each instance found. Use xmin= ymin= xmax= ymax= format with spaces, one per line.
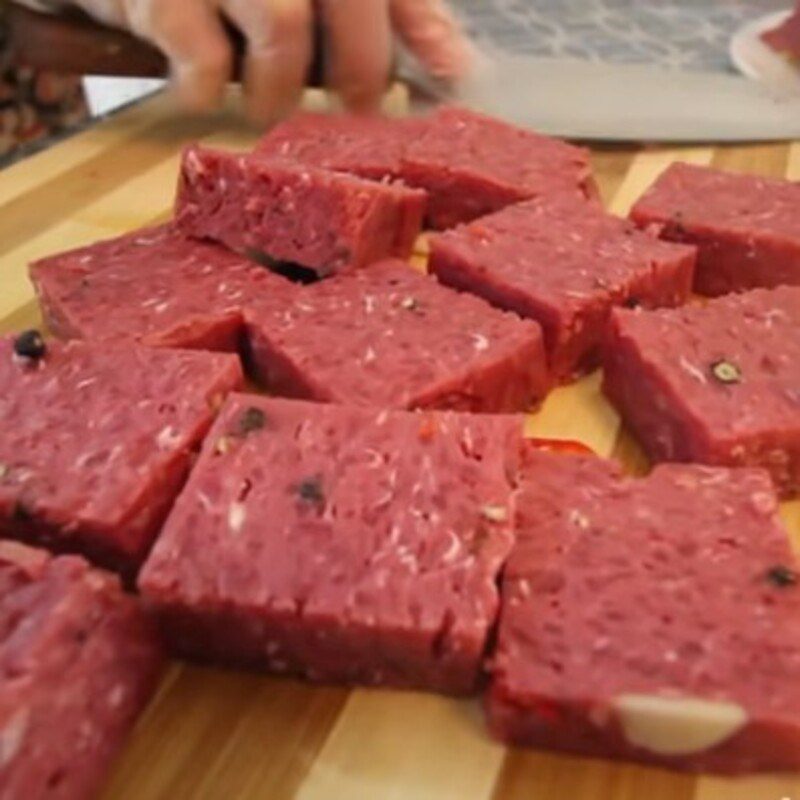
xmin=8 ymin=3 xmax=800 ymax=143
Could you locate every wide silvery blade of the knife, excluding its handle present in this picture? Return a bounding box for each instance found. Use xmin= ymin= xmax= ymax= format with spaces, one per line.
xmin=458 ymin=54 xmax=800 ymax=143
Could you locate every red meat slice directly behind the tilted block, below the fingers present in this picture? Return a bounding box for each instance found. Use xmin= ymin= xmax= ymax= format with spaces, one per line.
xmin=255 ymin=113 xmax=426 ymax=181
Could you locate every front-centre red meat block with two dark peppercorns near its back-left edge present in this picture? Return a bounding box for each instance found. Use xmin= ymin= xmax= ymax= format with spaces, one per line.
xmin=139 ymin=395 xmax=523 ymax=693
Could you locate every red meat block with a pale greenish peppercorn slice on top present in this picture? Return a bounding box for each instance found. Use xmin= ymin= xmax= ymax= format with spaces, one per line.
xmin=603 ymin=286 xmax=800 ymax=496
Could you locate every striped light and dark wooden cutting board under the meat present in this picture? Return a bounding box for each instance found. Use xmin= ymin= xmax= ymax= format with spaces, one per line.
xmin=0 ymin=87 xmax=800 ymax=800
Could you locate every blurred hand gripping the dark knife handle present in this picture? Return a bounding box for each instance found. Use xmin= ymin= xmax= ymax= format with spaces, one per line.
xmin=20 ymin=0 xmax=470 ymax=122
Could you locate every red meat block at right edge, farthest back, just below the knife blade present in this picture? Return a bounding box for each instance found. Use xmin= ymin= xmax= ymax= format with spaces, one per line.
xmin=631 ymin=163 xmax=800 ymax=297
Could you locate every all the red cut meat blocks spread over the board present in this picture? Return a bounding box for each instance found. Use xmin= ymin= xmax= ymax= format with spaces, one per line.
xmin=0 ymin=108 xmax=800 ymax=798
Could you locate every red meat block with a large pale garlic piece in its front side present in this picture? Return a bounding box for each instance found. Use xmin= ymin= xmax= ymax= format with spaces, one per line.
xmin=486 ymin=451 xmax=800 ymax=773
